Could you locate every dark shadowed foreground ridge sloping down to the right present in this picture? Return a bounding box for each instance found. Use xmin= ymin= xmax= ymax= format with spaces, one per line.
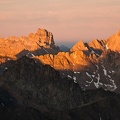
xmin=0 ymin=56 xmax=120 ymax=120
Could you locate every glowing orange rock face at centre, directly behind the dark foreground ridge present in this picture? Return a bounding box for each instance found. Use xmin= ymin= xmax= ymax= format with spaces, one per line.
xmin=36 ymin=51 xmax=91 ymax=71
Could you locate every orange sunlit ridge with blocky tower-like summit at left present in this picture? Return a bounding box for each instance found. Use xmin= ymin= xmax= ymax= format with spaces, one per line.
xmin=0 ymin=28 xmax=59 ymax=58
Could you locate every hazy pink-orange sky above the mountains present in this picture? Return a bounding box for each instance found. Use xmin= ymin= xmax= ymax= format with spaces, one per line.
xmin=0 ymin=0 xmax=120 ymax=45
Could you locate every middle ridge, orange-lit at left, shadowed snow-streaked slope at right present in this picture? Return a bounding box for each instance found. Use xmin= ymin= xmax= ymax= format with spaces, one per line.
xmin=36 ymin=50 xmax=120 ymax=92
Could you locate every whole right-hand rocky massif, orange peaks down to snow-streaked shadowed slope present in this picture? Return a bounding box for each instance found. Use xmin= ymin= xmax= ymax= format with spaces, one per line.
xmin=32 ymin=32 xmax=120 ymax=93
